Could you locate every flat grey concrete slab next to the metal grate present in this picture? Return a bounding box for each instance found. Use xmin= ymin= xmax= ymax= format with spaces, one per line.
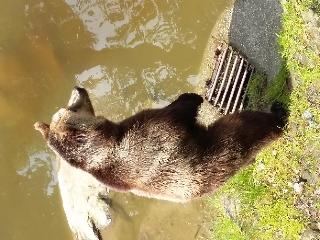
xmin=229 ymin=0 xmax=283 ymax=80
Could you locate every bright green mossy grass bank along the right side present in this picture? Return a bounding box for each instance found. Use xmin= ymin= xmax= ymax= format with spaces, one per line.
xmin=208 ymin=0 xmax=320 ymax=240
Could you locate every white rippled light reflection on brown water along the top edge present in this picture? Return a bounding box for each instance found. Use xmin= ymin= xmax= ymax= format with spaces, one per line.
xmin=65 ymin=0 xmax=196 ymax=51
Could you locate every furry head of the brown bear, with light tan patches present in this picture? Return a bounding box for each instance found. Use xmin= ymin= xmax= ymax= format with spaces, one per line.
xmin=34 ymin=87 xmax=106 ymax=167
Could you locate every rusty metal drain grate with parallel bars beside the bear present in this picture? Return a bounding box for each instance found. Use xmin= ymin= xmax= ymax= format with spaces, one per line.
xmin=206 ymin=43 xmax=254 ymax=114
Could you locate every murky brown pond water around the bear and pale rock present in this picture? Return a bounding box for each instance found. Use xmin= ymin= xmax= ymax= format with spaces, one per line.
xmin=0 ymin=0 xmax=229 ymax=240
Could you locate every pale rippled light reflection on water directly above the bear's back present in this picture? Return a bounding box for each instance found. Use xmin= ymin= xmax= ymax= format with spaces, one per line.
xmin=75 ymin=61 xmax=192 ymax=120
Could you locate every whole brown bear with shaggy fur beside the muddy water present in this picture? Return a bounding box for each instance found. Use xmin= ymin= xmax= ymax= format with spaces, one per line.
xmin=35 ymin=87 xmax=284 ymax=202
